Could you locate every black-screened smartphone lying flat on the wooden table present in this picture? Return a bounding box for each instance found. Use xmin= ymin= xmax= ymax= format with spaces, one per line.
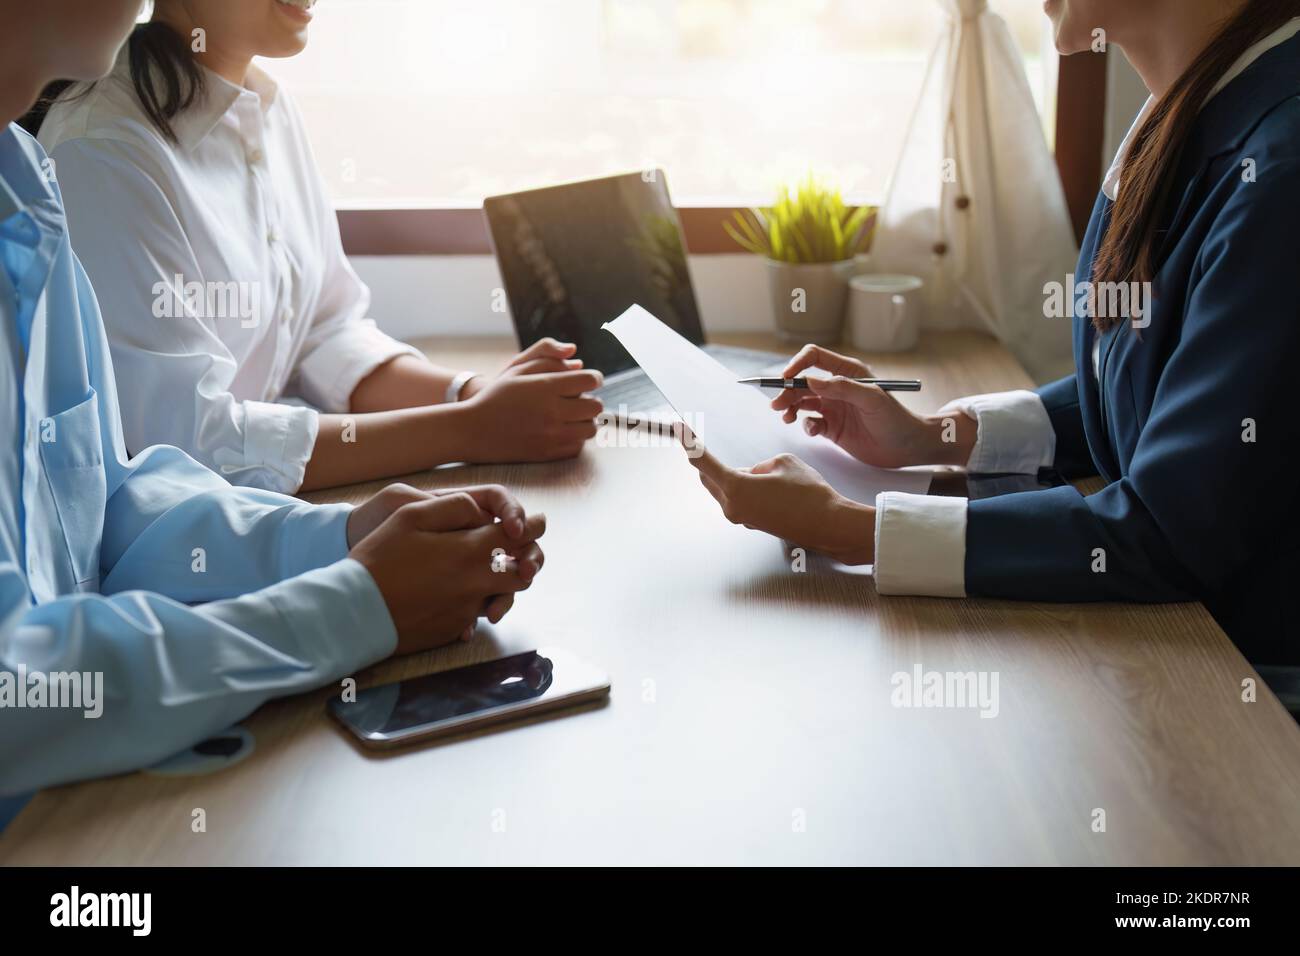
xmin=328 ymin=648 xmax=610 ymax=748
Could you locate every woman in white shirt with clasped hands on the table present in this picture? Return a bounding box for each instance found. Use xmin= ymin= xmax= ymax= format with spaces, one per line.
xmin=30 ymin=0 xmax=601 ymax=493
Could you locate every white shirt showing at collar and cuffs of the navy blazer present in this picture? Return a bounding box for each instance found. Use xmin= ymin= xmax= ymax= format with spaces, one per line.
xmin=875 ymin=17 xmax=1300 ymax=597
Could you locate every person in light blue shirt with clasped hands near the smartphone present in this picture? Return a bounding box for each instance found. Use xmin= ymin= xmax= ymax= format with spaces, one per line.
xmin=0 ymin=0 xmax=545 ymax=818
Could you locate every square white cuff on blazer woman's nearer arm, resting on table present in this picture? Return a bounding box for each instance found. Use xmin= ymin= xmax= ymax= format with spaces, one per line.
xmin=875 ymin=492 xmax=966 ymax=597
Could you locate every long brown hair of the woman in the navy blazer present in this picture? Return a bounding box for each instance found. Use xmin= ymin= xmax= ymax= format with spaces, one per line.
xmin=1092 ymin=0 xmax=1300 ymax=330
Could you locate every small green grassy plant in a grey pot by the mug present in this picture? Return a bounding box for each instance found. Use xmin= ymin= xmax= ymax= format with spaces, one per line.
xmin=723 ymin=174 xmax=875 ymax=345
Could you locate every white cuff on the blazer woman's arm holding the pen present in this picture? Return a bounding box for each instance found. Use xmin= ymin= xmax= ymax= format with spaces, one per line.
xmin=939 ymin=389 xmax=1056 ymax=475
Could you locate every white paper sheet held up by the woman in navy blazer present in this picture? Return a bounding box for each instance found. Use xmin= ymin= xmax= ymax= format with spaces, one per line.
xmin=603 ymin=306 xmax=930 ymax=505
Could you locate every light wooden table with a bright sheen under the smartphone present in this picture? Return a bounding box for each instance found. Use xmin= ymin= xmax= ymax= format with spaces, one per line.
xmin=0 ymin=334 xmax=1300 ymax=864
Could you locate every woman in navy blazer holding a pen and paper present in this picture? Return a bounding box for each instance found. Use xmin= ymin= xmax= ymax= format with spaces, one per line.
xmin=692 ymin=0 xmax=1300 ymax=665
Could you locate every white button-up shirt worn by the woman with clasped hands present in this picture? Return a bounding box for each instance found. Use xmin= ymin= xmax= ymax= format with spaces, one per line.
xmin=40 ymin=48 xmax=421 ymax=492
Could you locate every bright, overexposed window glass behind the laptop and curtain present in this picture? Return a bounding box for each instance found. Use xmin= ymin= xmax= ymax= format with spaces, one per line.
xmin=265 ymin=0 xmax=1056 ymax=207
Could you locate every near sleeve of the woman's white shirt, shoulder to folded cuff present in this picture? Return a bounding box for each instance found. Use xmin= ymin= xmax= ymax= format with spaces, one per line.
xmin=52 ymin=139 xmax=319 ymax=493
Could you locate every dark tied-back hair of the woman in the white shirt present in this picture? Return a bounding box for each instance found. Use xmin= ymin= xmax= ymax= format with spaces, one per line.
xmin=18 ymin=20 xmax=204 ymax=143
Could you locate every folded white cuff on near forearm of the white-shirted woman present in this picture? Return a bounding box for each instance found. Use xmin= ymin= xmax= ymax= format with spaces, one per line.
xmin=211 ymin=401 xmax=320 ymax=494
